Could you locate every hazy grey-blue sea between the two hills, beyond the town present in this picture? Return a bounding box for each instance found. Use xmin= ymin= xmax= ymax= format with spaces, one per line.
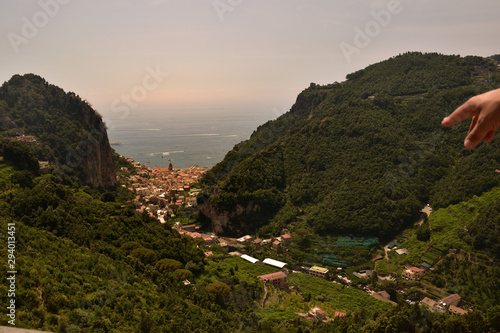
xmin=103 ymin=109 xmax=277 ymax=169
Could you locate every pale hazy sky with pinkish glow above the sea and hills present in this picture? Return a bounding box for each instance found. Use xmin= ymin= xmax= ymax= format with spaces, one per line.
xmin=0 ymin=0 xmax=500 ymax=118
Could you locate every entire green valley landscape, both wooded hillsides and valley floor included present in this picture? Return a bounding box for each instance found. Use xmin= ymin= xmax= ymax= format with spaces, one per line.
xmin=0 ymin=52 xmax=500 ymax=333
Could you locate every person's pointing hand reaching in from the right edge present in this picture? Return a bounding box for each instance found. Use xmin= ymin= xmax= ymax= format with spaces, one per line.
xmin=441 ymin=89 xmax=500 ymax=149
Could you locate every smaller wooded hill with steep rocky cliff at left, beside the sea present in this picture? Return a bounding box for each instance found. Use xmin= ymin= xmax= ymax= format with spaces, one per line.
xmin=0 ymin=74 xmax=116 ymax=187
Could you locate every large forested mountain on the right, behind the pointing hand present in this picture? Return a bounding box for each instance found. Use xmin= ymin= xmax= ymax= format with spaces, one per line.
xmin=199 ymin=52 xmax=500 ymax=238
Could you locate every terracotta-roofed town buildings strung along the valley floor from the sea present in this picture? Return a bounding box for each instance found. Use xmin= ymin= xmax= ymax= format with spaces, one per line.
xmin=121 ymin=159 xmax=467 ymax=321
